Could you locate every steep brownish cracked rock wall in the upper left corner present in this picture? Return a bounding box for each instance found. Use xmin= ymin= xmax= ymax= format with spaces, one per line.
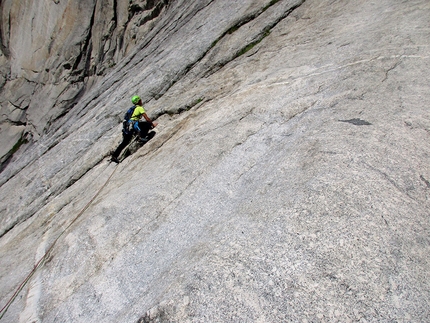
xmin=0 ymin=0 xmax=169 ymax=167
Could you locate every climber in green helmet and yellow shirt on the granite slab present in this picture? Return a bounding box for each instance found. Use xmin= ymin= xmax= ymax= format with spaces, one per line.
xmin=111 ymin=95 xmax=158 ymax=163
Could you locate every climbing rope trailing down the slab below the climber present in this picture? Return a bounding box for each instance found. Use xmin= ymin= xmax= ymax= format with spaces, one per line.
xmin=0 ymin=161 xmax=118 ymax=320
